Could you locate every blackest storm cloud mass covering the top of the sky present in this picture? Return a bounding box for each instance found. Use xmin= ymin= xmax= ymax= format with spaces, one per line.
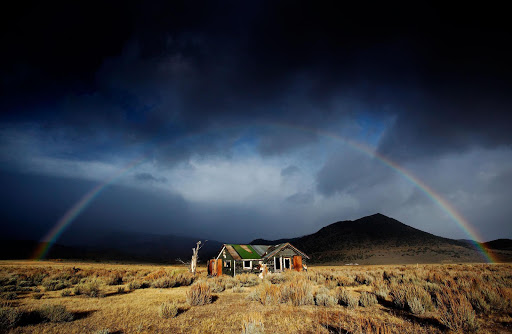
xmin=0 ymin=1 xmax=512 ymax=158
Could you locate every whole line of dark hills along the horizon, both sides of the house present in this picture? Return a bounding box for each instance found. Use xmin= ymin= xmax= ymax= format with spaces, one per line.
xmin=0 ymin=213 xmax=512 ymax=264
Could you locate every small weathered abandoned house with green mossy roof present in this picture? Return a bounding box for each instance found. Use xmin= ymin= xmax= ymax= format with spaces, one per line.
xmin=208 ymin=242 xmax=309 ymax=276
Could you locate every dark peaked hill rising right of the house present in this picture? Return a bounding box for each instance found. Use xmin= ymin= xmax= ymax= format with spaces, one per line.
xmin=251 ymin=213 xmax=504 ymax=264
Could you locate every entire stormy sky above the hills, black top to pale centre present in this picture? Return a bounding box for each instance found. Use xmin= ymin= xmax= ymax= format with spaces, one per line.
xmin=0 ymin=1 xmax=512 ymax=242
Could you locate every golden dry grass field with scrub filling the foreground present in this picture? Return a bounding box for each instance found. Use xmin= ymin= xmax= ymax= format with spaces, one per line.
xmin=0 ymin=261 xmax=512 ymax=334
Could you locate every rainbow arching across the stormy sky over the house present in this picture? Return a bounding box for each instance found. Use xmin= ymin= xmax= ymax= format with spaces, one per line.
xmin=32 ymin=123 xmax=497 ymax=263
